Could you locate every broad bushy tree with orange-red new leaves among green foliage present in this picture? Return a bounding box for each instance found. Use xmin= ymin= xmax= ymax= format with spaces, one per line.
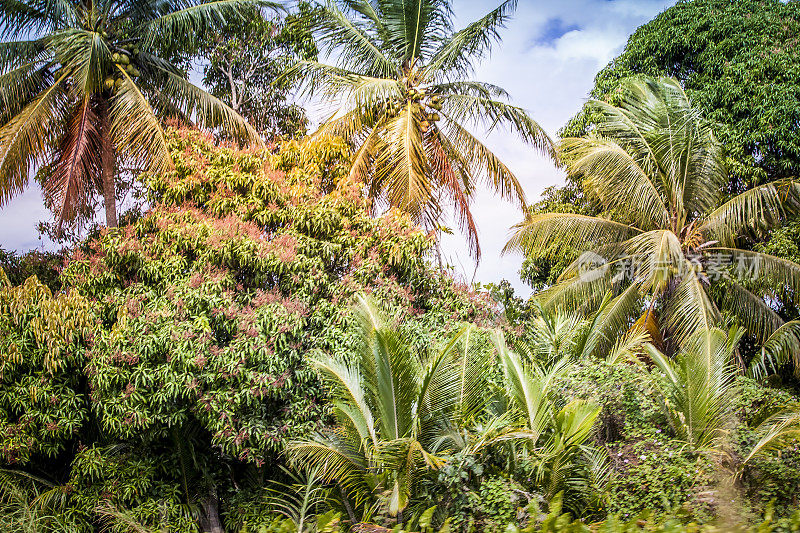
xmin=0 ymin=130 xmax=494 ymax=519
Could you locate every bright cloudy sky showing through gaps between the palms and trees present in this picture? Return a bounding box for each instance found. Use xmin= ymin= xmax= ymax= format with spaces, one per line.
xmin=0 ymin=0 xmax=674 ymax=296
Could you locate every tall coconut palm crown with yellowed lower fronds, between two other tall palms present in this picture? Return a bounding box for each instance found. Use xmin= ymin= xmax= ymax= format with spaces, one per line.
xmin=293 ymin=0 xmax=552 ymax=257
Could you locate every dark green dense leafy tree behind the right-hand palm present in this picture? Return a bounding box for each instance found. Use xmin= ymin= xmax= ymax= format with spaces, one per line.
xmin=564 ymin=0 xmax=800 ymax=192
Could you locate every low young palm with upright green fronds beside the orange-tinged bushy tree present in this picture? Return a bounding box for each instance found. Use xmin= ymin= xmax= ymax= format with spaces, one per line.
xmin=288 ymin=297 xmax=485 ymax=515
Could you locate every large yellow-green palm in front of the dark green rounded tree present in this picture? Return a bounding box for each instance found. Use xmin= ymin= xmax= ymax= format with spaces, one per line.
xmin=505 ymin=79 xmax=800 ymax=373
